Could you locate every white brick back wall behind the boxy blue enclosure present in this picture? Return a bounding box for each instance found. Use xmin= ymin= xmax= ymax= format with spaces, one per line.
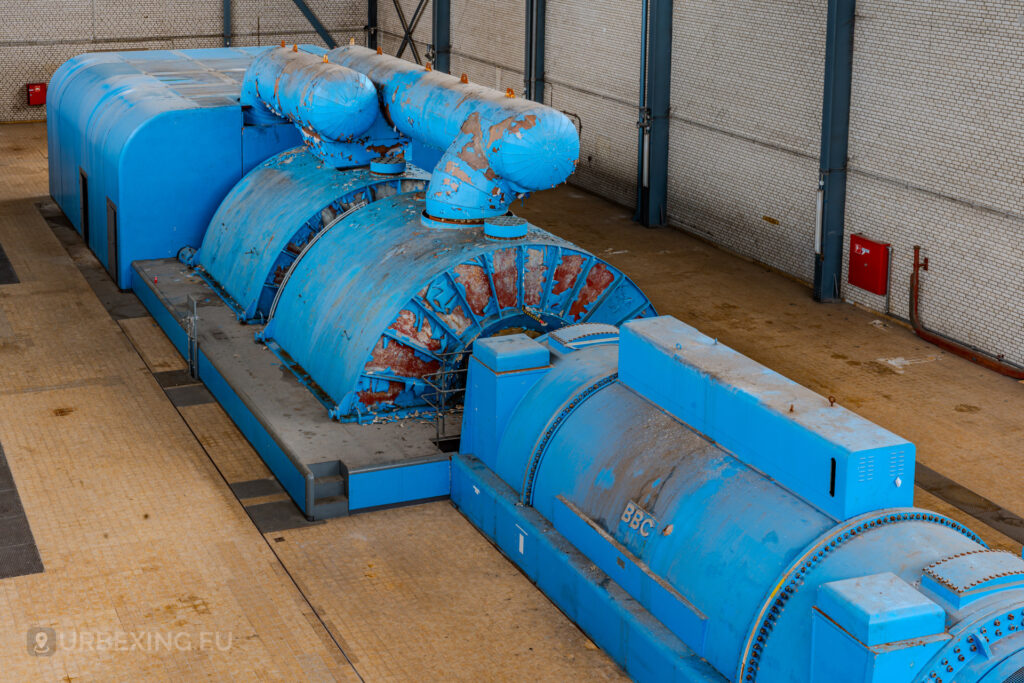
xmin=0 ymin=0 xmax=367 ymax=121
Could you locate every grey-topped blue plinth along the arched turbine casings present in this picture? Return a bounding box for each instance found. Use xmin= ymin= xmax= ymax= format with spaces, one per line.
xmin=132 ymin=258 xmax=450 ymax=519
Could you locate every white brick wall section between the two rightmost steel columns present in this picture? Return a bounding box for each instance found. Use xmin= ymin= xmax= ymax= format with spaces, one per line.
xmin=669 ymin=0 xmax=826 ymax=281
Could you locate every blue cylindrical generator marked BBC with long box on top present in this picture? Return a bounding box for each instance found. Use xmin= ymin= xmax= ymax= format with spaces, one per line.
xmin=453 ymin=317 xmax=1024 ymax=683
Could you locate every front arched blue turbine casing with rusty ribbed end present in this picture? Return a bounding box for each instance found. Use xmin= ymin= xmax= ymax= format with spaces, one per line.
xmin=252 ymin=188 xmax=653 ymax=420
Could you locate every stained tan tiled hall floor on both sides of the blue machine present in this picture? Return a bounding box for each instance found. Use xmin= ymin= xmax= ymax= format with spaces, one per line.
xmin=0 ymin=124 xmax=1024 ymax=681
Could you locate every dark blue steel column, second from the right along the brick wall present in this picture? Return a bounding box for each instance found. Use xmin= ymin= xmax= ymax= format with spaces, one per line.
xmin=634 ymin=0 xmax=672 ymax=227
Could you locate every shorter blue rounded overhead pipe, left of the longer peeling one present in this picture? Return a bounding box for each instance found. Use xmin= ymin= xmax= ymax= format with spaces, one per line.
xmin=242 ymin=47 xmax=398 ymax=168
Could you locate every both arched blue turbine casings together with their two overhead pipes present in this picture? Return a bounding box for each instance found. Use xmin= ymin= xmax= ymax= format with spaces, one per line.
xmin=182 ymin=47 xmax=638 ymax=421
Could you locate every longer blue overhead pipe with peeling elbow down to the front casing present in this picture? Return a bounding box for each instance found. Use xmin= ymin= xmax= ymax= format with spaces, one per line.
xmin=330 ymin=45 xmax=580 ymax=220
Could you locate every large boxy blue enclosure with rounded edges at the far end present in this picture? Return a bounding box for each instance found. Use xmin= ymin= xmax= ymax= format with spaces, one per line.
xmin=47 ymin=48 xmax=299 ymax=288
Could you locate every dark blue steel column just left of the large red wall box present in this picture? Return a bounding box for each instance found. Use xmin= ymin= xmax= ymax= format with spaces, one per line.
xmin=814 ymin=0 xmax=857 ymax=301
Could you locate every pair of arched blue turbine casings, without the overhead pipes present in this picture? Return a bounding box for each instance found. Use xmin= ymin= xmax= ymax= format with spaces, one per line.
xmin=186 ymin=144 xmax=653 ymax=421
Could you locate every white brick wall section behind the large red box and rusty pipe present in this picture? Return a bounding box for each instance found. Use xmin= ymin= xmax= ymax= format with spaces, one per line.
xmin=844 ymin=0 xmax=1024 ymax=364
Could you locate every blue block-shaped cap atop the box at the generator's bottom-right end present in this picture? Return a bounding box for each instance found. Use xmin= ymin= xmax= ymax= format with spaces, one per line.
xmin=817 ymin=571 xmax=946 ymax=646
